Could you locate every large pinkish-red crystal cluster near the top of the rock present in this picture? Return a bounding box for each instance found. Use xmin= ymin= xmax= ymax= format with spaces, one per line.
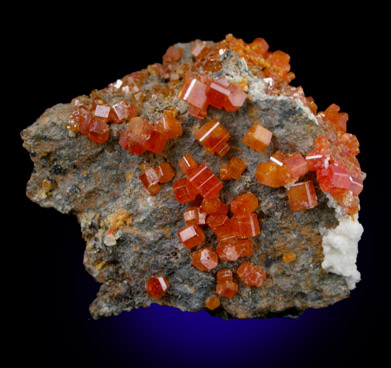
xmin=179 ymin=74 xmax=246 ymax=119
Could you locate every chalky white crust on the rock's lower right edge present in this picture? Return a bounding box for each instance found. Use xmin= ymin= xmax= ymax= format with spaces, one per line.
xmin=320 ymin=199 xmax=364 ymax=290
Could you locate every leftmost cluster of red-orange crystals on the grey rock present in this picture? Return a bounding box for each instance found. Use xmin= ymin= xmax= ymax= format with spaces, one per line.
xmin=68 ymin=99 xmax=138 ymax=143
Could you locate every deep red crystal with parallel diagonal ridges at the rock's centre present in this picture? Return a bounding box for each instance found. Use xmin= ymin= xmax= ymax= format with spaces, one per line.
xmin=188 ymin=164 xmax=223 ymax=199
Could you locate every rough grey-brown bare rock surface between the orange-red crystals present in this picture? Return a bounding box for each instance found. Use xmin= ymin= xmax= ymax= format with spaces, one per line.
xmin=22 ymin=37 xmax=356 ymax=318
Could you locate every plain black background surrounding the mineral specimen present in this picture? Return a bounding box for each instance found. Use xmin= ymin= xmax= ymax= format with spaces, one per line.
xmin=10 ymin=3 xmax=390 ymax=368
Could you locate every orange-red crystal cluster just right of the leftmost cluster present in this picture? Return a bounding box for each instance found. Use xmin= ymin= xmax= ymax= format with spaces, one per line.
xmin=119 ymin=110 xmax=182 ymax=155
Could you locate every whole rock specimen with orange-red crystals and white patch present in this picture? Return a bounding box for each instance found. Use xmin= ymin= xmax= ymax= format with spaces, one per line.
xmin=22 ymin=34 xmax=365 ymax=318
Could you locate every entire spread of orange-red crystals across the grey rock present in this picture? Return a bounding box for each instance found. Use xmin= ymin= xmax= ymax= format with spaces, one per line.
xmin=44 ymin=34 xmax=365 ymax=310
